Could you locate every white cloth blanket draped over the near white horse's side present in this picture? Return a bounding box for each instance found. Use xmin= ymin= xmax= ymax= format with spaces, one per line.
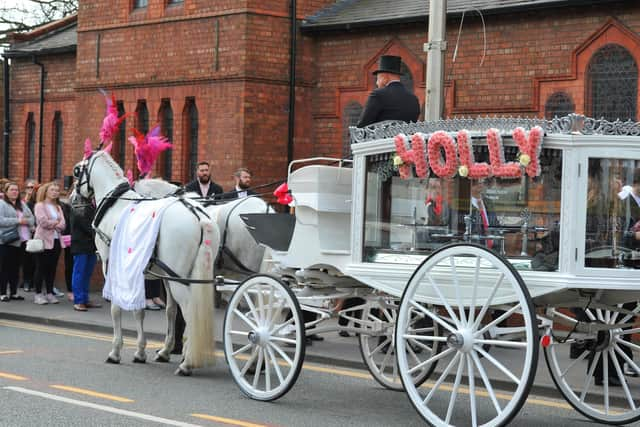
xmin=102 ymin=197 xmax=178 ymax=311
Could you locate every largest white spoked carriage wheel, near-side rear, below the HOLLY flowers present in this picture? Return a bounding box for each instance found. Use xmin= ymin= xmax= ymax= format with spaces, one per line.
xmin=396 ymin=244 xmax=538 ymax=426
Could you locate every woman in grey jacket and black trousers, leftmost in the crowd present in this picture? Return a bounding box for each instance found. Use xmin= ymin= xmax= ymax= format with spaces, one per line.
xmin=0 ymin=182 xmax=34 ymax=302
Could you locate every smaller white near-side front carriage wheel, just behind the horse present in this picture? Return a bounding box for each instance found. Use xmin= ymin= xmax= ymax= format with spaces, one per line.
xmin=224 ymin=275 xmax=305 ymax=401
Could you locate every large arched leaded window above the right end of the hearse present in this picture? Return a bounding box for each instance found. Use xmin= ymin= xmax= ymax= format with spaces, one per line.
xmin=586 ymin=44 xmax=638 ymax=121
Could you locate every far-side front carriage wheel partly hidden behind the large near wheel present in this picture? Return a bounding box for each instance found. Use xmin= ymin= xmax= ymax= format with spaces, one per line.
xmin=359 ymin=298 xmax=439 ymax=391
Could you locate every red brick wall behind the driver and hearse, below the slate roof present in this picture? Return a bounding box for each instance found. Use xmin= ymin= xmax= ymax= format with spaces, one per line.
xmin=311 ymin=2 xmax=640 ymax=155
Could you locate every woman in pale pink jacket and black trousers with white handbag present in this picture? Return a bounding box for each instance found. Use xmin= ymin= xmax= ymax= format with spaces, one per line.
xmin=33 ymin=182 xmax=65 ymax=304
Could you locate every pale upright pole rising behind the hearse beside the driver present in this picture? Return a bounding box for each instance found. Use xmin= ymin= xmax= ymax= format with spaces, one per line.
xmin=424 ymin=0 xmax=447 ymax=121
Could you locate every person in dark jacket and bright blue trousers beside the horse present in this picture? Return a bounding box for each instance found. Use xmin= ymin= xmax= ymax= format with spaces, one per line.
xmin=71 ymin=192 xmax=101 ymax=311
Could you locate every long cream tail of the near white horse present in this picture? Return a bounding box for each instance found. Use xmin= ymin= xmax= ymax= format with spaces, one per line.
xmin=187 ymin=219 xmax=220 ymax=368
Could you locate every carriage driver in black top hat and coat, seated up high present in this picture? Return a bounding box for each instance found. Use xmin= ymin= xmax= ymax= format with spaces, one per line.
xmin=358 ymin=55 xmax=420 ymax=127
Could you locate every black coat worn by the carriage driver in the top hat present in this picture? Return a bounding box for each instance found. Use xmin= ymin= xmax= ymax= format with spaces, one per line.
xmin=358 ymin=82 xmax=420 ymax=128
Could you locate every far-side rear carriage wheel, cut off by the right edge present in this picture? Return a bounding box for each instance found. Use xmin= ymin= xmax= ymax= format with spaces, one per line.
xmin=544 ymin=302 xmax=640 ymax=424
